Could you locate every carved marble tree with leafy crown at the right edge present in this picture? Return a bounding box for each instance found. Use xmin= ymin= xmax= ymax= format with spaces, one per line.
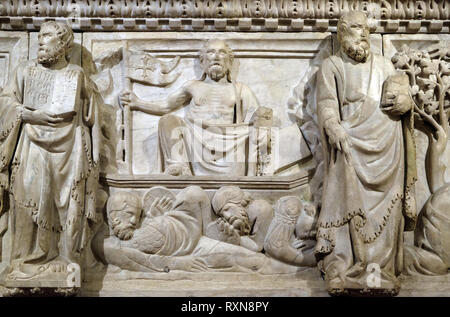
xmin=392 ymin=43 xmax=450 ymax=193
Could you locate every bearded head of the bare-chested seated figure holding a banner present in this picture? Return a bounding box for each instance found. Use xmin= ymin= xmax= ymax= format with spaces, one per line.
xmin=199 ymin=40 xmax=233 ymax=82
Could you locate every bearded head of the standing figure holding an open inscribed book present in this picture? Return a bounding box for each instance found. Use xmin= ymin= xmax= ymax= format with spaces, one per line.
xmin=38 ymin=21 xmax=73 ymax=66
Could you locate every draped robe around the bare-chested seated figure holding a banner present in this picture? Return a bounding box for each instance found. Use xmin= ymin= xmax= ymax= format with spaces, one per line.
xmin=159 ymin=83 xmax=259 ymax=176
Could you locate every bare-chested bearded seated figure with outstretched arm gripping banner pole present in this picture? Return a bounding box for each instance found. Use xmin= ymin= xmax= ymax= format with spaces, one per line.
xmin=121 ymin=40 xmax=259 ymax=175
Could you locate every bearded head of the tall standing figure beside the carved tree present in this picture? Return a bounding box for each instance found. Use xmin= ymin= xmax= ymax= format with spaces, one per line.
xmin=337 ymin=11 xmax=370 ymax=63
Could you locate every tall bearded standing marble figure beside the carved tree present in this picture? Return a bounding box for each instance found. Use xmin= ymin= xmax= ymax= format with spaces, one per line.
xmin=315 ymin=12 xmax=415 ymax=294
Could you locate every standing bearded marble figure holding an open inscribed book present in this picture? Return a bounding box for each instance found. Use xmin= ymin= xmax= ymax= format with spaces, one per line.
xmin=0 ymin=21 xmax=99 ymax=280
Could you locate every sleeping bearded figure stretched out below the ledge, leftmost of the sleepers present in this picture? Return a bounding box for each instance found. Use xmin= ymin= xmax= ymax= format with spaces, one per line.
xmin=93 ymin=186 xmax=276 ymax=272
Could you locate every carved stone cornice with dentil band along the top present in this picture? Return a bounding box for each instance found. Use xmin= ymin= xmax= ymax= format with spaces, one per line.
xmin=0 ymin=0 xmax=450 ymax=33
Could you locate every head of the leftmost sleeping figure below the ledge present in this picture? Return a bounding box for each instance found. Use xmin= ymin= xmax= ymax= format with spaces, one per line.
xmin=107 ymin=192 xmax=142 ymax=240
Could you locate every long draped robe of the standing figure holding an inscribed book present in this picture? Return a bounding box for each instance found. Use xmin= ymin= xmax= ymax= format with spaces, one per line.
xmin=0 ymin=61 xmax=99 ymax=263
